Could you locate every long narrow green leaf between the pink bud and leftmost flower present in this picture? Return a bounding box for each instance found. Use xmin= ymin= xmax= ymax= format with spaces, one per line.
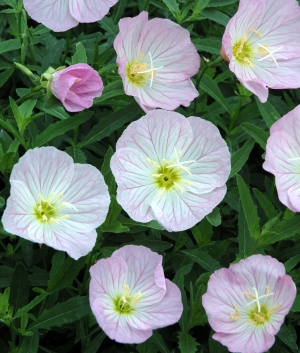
xmin=32 ymin=112 xmax=93 ymax=148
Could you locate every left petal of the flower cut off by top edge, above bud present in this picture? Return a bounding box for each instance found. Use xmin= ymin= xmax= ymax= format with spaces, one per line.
xmin=23 ymin=0 xmax=78 ymax=32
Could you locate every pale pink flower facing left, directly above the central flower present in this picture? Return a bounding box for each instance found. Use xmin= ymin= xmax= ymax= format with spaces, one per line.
xmin=114 ymin=11 xmax=200 ymax=111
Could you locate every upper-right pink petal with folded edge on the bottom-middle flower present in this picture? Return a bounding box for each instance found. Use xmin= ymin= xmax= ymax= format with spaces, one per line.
xmin=112 ymin=245 xmax=166 ymax=304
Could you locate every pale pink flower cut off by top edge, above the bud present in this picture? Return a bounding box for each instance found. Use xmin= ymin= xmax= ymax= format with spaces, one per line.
xmin=23 ymin=0 xmax=118 ymax=32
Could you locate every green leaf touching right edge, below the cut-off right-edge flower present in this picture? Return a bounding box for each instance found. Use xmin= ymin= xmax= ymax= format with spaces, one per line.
xmin=259 ymin=216 xmax=300 ymax=246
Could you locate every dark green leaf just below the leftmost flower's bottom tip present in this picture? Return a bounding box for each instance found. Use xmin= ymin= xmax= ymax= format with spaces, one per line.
xmin=47 ymin=256 xmax=86 ymax=293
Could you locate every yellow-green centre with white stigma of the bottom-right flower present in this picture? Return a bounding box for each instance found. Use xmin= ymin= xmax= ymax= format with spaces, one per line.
xmin=229 ymin=285 xmax=280 ymax=326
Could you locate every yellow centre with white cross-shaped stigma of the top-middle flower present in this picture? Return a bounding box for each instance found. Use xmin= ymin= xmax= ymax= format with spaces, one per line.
xmin=126 ymin=52 xmax=163 ymax=88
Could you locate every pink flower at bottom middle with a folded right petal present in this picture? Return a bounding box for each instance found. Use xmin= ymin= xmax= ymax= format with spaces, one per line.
xmin=90 ymin=245 xmax=183 ymax=343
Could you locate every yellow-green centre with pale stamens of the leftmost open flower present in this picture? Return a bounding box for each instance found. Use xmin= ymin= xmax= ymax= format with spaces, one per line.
xmin=33 ymin=193 xmax=77 ymax=224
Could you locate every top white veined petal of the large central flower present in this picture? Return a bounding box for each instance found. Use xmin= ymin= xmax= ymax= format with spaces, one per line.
xmin=116 ymin=110 xmax=192 ymax=163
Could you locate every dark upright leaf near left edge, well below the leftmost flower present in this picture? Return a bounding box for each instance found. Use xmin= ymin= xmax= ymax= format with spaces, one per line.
xmin=9 ymin=262 xmax=29 ymax=312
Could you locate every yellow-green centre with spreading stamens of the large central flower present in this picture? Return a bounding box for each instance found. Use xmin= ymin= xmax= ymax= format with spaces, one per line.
xmin=146 ymin=147 xmax=196 ymax=196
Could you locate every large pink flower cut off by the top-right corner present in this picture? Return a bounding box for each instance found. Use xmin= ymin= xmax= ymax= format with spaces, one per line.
xmin=221 ymin=0 xmax=300 ymax=103
